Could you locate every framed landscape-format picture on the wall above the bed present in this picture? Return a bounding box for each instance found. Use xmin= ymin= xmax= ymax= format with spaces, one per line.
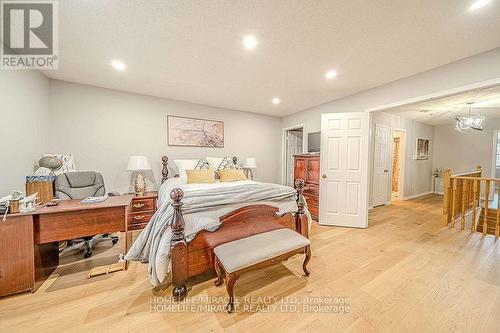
xmin=167 ymin=116 xmax=224 ymax=148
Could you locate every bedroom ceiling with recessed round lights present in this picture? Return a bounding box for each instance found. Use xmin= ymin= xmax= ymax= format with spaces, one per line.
xmin=44 ymin=0 xmax=500 ymax=116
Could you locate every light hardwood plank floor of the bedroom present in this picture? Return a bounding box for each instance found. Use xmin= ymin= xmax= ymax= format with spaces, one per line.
xmin=0 ymin=195 xmax=500 ymax=332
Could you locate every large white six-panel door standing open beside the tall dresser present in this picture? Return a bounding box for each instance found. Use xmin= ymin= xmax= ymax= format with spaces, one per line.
xmin=319 ymin=112 xmax=370 ymax=228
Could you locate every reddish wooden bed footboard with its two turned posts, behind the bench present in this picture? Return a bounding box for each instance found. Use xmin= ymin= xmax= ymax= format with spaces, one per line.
xmin=170 ymin=179 xmax=309 ymax=301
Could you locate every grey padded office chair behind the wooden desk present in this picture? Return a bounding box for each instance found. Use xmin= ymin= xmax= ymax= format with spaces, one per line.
xmin=55 ymin=171 xmax=118 ymax=258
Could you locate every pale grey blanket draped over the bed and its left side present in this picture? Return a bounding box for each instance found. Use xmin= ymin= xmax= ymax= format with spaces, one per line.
xmin=125 ymin=180 xmax=304 ymax=286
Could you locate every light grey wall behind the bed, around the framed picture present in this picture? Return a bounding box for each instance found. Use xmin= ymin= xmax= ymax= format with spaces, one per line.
xmin=49 ymin=80 xmax=281 ymax=193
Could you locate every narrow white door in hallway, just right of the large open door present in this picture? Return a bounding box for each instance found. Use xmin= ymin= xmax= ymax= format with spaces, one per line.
xmin=372 ymin=124 xmax=391 ymax=206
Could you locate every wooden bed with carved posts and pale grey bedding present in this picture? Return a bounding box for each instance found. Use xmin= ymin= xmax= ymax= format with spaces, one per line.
xmin=125 ymin=156 xmax=311 ymax=300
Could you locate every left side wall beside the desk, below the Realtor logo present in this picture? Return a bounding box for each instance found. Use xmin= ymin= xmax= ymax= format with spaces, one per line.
xmin=0 ymin=70 xmax=50 ymax=197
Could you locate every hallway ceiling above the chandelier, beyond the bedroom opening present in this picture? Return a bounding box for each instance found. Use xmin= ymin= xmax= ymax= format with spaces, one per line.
xmin=384 ymin=86 xmax=500 ymax=126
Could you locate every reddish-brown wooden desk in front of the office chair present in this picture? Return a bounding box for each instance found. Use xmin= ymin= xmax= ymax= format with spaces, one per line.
xmin=0 ymin=195 xmax=132 ymax=296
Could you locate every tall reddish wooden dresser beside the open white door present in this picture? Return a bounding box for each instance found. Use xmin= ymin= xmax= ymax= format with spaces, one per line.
xmin=293 ymin=154 xmax=319 ymax=221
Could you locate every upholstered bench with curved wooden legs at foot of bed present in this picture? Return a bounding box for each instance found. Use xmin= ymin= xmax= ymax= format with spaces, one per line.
xmin=214 ymin=229 xmax=311 ymax=312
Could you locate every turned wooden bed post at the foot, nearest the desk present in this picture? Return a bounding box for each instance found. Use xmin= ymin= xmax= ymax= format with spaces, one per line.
xmin=171 ymin=188 xmax=188 ymax=301
